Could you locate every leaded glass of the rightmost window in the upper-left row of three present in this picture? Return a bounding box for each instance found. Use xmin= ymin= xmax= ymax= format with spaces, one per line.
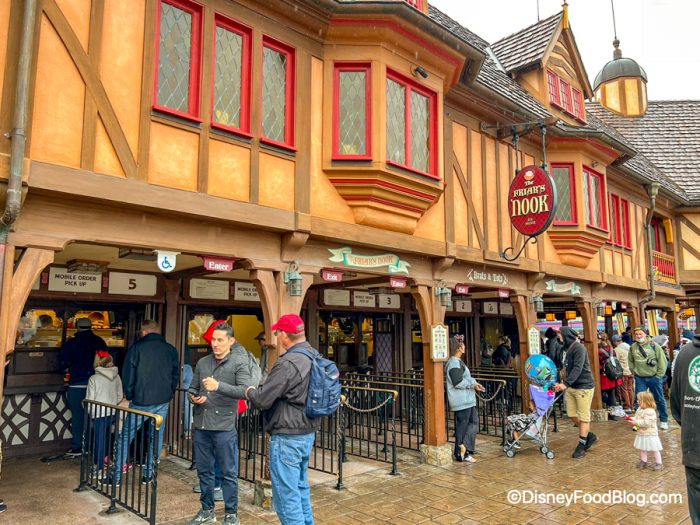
xmin=262 ymin=47 xmax=289 ymax=143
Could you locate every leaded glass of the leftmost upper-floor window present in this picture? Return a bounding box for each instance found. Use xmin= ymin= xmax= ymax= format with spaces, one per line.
xmin=156 ymin=2 xmax=192 ymax=113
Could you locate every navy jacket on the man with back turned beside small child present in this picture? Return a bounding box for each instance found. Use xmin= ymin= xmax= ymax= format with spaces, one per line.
xmin=123 ymin=333 xmax=180 ymax=406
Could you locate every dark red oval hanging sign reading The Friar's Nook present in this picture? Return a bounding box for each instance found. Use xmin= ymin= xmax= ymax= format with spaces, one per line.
xmin=508 ymin=165 xmax=557 ymax=236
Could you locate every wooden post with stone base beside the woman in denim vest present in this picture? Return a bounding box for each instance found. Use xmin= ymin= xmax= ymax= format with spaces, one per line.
xmin=411 ymin=285 xmax=452 ymax=465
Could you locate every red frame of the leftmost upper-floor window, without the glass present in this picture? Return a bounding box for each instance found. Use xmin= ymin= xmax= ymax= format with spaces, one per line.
xmin=153 ymin=0 xmax=203 ymax=122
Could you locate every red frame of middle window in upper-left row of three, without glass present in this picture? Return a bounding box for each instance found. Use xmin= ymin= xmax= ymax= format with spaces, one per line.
xmin=211 ymin=13 xmax=253 ymax=137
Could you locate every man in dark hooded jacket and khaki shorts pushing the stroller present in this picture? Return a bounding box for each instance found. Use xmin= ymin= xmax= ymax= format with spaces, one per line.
xmin=554 ymin=326 xmax=598 ymax=459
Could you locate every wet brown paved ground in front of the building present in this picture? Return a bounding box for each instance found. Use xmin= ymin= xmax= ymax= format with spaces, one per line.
xmin=0 ymin=421 xmax=690 ymax=525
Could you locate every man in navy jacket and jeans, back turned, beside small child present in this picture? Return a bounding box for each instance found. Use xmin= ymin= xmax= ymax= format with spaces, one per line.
xmin=108 ymin=319 xmax=180 ymax=484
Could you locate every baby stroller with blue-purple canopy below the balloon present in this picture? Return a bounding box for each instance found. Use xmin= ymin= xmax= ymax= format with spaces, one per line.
xmin=503 ymin=385 xmax=561 ymax=459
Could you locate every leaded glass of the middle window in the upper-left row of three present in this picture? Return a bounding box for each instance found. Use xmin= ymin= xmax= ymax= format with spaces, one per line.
xmin=212 ymin=25 xmax=244 ymax=129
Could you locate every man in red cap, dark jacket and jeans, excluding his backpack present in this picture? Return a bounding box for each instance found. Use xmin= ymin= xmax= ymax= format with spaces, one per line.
xmin=246 ymin=314 xmax=319 ymax=525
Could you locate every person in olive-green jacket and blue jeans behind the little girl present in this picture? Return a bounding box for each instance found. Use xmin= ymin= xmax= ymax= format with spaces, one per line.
xmin=627 ymin=326 xmax=668 ymax=430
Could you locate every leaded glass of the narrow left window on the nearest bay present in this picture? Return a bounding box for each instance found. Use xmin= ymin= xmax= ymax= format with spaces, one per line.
xmin=338 ymin=71 xmax=368 ymax=155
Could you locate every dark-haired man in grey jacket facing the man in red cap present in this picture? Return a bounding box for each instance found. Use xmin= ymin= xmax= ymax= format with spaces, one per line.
xmin=188 ymin=323 xmax=260 ymax=525
